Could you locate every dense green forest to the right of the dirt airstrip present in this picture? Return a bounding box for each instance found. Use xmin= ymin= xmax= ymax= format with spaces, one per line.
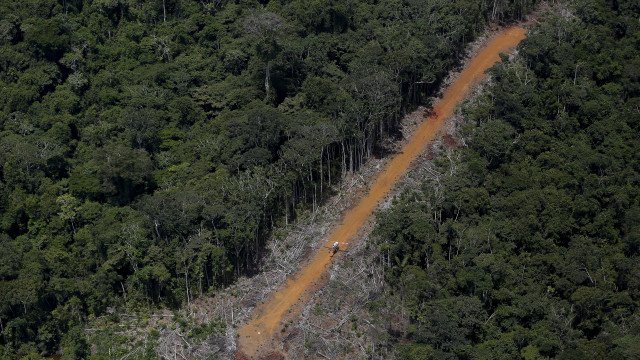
xmin=376 ymin=1 xmax=640 ymax=360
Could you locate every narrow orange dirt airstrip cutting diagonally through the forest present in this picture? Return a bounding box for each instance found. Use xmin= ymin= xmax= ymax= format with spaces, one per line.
xmin=238 ymin=27 xmax=526 ymax=358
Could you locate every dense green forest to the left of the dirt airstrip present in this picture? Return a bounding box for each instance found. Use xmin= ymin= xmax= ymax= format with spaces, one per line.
xmin=0 ymin=0 xmax=535 ymax=358
